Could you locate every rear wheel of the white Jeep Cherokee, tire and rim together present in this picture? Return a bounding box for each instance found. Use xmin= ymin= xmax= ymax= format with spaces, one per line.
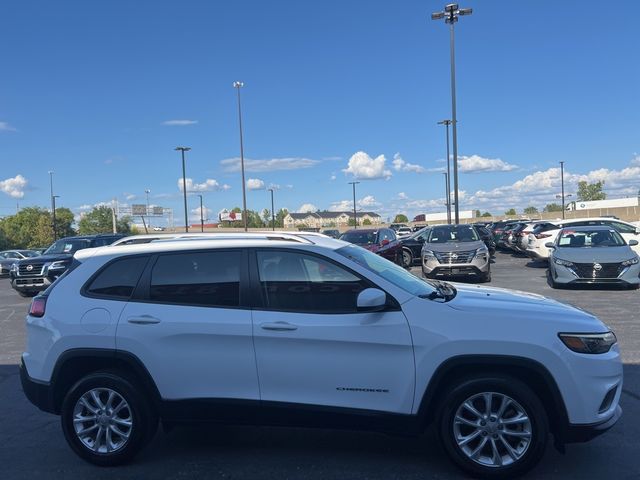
xmin=61 ymin=371 xmax=158 ymax=466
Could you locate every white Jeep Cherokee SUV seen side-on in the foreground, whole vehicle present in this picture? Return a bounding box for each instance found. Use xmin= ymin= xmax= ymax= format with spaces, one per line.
xmin=21 ymin=233 xmax=622 ymax=478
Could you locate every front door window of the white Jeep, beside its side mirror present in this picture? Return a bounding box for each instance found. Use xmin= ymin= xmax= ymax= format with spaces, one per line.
xmin=257 ymin=250 xmax=368 ymax=313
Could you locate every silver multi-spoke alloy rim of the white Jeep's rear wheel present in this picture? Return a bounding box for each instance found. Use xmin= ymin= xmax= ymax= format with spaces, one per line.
xmin=73 ymin=388 xmax=133 ymax=454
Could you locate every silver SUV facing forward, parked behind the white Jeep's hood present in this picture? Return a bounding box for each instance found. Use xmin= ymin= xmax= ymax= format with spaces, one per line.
xmin=422 ymin=225 xmax=491 ymax=282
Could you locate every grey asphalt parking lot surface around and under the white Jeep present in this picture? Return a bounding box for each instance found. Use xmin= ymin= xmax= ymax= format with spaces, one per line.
xmin=0 ymin=252 xmax=640 ymax=480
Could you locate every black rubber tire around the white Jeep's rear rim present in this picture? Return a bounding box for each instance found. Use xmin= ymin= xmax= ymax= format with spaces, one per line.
xmin=61 ymin=371 xmax=158 ymax=466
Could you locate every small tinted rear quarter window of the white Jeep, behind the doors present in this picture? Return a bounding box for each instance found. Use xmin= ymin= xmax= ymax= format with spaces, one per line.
xmin=86 ymin=256 xmax=149 ymax=300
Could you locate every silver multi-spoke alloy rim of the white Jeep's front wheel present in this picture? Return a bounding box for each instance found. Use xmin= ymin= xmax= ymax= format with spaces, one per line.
xmin=453 ymin=392 xmax=533 ymax=468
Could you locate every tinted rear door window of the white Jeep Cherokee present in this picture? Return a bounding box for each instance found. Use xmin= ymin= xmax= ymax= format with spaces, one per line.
xmin=149 ymin=251 xmax=242 ymax=307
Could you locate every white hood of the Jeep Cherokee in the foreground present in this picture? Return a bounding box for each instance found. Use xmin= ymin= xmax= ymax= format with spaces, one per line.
xmin=447 ymin=283 xmax=599 ymax=322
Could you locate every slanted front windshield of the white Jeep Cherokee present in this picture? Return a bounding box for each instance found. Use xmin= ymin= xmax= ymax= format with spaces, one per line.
xmin=336 ymin=245 xmax=435 ymax=297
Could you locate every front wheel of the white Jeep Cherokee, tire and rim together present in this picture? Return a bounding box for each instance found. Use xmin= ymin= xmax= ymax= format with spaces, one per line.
xmin=439 ymin=375 xmax=549 ymax=479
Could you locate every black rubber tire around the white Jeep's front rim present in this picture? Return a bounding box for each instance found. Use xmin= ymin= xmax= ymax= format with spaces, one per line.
xmin=438 ymin=374 xmax=549 ymax=479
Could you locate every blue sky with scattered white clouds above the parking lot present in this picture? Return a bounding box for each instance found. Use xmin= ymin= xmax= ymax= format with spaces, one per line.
xmin=0 ymin=0 xmax=640 ymax=225
